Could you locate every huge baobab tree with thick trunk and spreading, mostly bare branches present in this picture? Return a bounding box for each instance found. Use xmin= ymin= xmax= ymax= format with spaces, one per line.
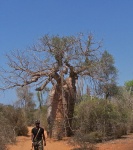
xmin=1 ymin=34 xmax=116 ymax=137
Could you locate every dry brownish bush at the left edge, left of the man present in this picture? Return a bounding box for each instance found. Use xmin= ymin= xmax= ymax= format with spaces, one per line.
xmin=0 ymin=105 xmax=28 ymax=150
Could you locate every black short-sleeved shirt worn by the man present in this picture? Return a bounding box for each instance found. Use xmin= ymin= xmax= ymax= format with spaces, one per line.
xmin=31 ymin=127 xmax=44 ymax=141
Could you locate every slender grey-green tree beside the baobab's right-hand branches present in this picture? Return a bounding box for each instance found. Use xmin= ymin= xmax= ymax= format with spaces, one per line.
xmin=98 ymin=51 xmax=118 ymax=99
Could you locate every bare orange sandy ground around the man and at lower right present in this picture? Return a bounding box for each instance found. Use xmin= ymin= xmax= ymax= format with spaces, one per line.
xmin=8 ymin=128 xmax=133 ymax=150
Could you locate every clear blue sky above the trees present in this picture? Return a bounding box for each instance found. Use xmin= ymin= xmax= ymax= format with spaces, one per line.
xmin=0 ymin=0 xmax=133 ymax=103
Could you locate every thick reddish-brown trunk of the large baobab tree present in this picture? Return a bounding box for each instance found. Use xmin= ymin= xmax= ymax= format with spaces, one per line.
xmin=48 ymin=78 xmax=76 ymax=139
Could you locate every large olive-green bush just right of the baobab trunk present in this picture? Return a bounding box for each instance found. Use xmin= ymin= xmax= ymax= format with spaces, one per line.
xmin=73 ymin=98 xmax=129 ymax=142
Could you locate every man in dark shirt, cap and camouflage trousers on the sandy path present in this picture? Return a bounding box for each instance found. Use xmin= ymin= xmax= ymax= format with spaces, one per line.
xmin=31 ymin=120 xmax=46 ymax=150
